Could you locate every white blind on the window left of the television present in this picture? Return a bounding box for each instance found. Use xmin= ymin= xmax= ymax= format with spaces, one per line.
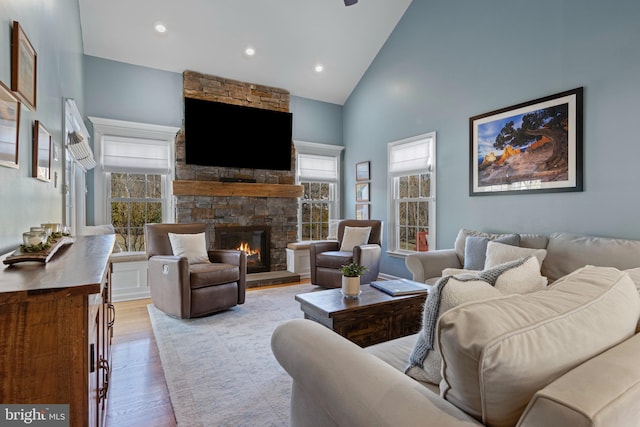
xmin=102 ymin=135 xmax=171 ymax=174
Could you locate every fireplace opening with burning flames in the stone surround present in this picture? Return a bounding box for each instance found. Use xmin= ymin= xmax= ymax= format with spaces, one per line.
xmin=214 ymin=225 xmax=271 ymax=273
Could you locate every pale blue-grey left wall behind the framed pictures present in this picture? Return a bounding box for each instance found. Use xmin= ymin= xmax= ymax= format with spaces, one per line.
xmin=0 ymin=0 xmax=84 ymax=253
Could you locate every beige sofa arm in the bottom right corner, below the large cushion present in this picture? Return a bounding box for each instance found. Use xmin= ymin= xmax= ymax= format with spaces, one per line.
xmin=517 ymin=334 xmax=640 ymax=427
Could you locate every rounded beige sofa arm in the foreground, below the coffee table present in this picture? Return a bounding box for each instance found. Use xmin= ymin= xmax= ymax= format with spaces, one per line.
xmin=271 ymin=319 xmax=481 ymax=427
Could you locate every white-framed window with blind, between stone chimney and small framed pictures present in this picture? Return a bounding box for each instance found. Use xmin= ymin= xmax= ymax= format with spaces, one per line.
xmin=295 ymin=141 xmax=342 ymax=240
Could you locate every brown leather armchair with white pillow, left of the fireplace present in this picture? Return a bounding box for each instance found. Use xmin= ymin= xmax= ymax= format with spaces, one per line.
xmin=144 ymin=224 xmax=247 ymax=319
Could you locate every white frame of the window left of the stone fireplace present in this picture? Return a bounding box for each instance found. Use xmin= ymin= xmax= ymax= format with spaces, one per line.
xmin=89 ymin=117 xmax=180 ymax=251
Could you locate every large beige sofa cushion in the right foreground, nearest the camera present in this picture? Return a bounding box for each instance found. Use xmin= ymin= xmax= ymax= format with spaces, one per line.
xmin=437 ymin=266 xmax=640 ymax=426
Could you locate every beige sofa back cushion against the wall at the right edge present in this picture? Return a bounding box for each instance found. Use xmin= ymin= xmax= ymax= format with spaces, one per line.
xmin=542 ymin=233 xmax=640 ymax=283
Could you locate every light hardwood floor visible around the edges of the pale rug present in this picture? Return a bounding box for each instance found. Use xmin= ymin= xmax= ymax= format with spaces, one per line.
xmin=106 ymin=282 xmax=304 ymax=427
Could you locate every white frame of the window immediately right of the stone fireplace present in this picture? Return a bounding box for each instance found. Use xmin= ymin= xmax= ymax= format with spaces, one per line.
xmin=293 ymin=141 xmax=344 ymax=240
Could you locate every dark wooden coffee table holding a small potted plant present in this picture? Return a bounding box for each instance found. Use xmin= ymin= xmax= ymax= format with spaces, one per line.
xmin=296 ymin=285 xmax=427 ymax=347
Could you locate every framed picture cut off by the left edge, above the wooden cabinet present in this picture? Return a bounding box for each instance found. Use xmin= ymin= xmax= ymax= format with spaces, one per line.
xmin=0 ymin=82 xmax=20 ymax=169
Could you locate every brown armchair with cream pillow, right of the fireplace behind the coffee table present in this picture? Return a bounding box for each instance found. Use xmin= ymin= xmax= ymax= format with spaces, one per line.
xmin=309 ymin=219 xmax=382 ymax=288
